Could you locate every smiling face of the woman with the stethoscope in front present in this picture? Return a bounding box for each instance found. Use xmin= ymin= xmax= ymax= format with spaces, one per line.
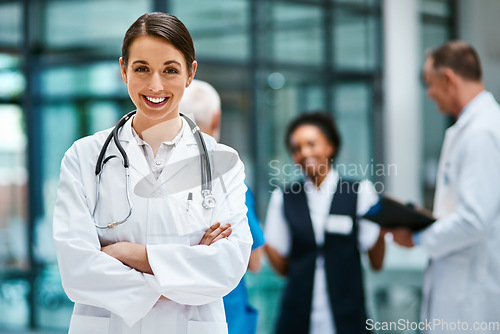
xmin=120 ymin=36 xmax=197 ymax=125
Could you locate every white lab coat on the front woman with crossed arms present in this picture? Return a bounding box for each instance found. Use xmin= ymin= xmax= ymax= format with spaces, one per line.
xmin=53 ymin=116 xmax=252 ymax=334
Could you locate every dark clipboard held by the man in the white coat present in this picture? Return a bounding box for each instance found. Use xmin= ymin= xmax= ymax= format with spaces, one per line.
xmin=363 ymin=196 xmax=436 ymax=231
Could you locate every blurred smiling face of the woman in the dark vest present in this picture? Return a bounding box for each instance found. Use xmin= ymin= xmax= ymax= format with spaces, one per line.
xmin=290 ymin=124 xmax=335 ymax=185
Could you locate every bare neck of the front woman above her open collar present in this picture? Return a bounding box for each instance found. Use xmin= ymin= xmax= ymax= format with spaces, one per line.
xmin=132 ymin=114 xmax=182 ymax=155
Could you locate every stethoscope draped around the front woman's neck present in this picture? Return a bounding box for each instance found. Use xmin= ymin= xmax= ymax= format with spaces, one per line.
xmin=92 ymin=110 xmax=217 ymax=229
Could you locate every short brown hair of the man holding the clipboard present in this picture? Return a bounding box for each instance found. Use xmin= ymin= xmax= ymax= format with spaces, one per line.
xmin=428 ymin=41 xmax=482 ymax=81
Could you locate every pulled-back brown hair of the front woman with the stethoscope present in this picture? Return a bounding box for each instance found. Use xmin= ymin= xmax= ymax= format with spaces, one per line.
xmin=122 ymin=12 xmax=195 ymax=73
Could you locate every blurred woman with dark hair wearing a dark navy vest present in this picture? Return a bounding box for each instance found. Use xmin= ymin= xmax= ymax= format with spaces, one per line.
xmin=265 ymin=113 xmax=385 ymax=334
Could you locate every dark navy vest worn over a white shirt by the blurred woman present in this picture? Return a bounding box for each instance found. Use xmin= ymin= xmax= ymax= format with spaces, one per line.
xmin=277 ymin=179 xmax=367 ymax=334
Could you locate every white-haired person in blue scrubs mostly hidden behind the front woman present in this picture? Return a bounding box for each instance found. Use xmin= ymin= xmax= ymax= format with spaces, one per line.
xmin=179 ymin=79 xmax=264 ymax=334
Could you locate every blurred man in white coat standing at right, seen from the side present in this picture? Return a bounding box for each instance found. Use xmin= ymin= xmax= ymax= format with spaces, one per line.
xmin=392 ymin=41 xmax=500 ymax=334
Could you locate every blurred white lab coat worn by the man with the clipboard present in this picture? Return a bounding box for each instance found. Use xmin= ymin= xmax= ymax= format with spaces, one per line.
xmin=420 ymin=92 xmax=500 ymax=333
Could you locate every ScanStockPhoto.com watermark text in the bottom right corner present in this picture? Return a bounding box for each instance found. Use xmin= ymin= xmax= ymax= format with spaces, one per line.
xmin=366 ymin=319 xmax=500 ymax=334
